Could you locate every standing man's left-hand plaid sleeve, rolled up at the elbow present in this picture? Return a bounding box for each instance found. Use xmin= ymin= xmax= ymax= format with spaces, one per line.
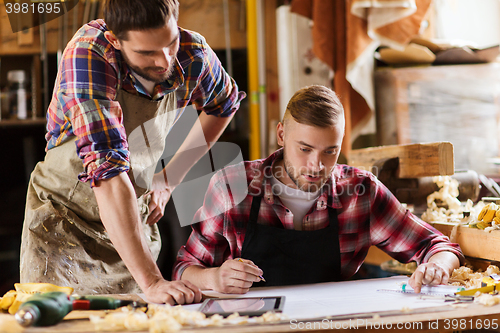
xmin=47 ymin=39 xmax=130 ymax=186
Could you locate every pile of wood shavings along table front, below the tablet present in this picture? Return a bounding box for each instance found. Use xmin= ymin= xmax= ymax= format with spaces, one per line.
xmin=89 ymin=304 xmax=288 ymax=333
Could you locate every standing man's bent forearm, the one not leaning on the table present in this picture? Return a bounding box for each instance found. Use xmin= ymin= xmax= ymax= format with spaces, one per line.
xmin=163 ymin=112 xmax=233 ymax=189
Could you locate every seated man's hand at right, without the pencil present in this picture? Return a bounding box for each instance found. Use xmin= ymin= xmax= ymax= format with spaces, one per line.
xmin=408 ymin=251 xmax=460 ymax=293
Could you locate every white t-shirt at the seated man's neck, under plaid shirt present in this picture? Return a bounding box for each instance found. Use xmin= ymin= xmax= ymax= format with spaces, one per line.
xmin=271 ymin=176 xmax=321 ymax=230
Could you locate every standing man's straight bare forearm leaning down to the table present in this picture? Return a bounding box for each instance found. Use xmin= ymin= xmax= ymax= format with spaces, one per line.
xmin=94 ymin=173 xmax=162 ymax=291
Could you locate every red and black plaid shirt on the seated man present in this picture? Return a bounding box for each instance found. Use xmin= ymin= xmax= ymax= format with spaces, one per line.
xmin=173 ymin=149 xmax=463 ymax=280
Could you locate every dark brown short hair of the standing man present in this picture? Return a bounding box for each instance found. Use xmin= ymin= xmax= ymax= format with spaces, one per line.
xmin=103 ymin=0 xmax=179 ymax=40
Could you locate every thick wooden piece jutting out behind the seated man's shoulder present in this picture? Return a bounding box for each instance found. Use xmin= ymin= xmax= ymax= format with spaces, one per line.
xmin=348 ymin=142 xmax=455 ymax=178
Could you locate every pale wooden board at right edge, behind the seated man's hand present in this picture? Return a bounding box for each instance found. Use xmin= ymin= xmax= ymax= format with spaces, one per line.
xmin=431 ymin=222 xmax=500 ymax=261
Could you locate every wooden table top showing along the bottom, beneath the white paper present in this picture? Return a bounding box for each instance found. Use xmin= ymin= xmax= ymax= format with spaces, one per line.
xmin=0 ymin=296 xmax=500 ymax=333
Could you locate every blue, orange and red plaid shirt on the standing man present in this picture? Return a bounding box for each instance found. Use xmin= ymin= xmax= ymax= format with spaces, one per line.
xmin=46 ymin=20 xmax=245 ymax=186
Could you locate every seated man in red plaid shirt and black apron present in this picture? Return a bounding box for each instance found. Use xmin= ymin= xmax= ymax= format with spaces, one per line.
xmin=173 ymin=85 xmax=463 ymax=293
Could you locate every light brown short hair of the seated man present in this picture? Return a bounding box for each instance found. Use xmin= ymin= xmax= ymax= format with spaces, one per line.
xmin=282 ymin=85 xmax=345 ymax=127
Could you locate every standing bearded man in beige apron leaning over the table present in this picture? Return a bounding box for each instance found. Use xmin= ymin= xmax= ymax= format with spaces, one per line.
xmin=20 ymin=0 xmax=245 ymax=304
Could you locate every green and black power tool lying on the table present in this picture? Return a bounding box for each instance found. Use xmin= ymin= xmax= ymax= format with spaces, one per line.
xmin=15 ymin=291 xmax=147 ymax=327
